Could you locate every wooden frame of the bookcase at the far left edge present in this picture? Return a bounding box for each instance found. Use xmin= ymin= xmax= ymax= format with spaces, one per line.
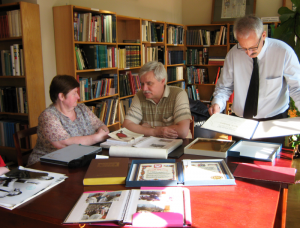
xmin=0 ymin=2 xmax=45 ymax=155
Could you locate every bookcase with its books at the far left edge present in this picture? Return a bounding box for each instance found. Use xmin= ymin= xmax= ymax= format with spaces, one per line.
xmin=0 ymin=2 xmax=45 ymax=156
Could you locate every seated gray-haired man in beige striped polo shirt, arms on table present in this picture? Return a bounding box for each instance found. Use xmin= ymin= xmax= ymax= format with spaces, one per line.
xmin=123 ymin=61 xmax=192 ymax=139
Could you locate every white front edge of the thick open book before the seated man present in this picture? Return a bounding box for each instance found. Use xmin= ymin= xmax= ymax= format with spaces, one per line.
xmin=109 ymin=146 xmax=168 ymax=159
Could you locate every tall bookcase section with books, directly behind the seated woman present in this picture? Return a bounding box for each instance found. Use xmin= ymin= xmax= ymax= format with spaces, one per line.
xmin=53 ymin=5 xmax=120 ymax=131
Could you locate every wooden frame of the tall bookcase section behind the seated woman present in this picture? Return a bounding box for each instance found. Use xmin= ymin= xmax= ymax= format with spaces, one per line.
xmin=53 ymin=5 xmax=123 ymax=131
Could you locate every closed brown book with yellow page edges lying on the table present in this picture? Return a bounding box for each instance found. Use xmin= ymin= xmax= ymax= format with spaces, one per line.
xmin=83 ymin=158 xmax=129 ymax=185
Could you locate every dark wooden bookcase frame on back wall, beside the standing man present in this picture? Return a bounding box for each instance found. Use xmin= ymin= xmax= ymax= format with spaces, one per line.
xmin=186 ymin=24 xmax=231 ymax=103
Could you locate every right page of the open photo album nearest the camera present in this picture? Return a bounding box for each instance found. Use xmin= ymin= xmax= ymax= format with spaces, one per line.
xmin=123 ymin=188 xmax=184 ymax=225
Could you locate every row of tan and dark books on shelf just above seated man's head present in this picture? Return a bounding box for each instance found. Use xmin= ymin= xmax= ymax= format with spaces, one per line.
xmin=118 ymin=45 xmax=141 ymax=69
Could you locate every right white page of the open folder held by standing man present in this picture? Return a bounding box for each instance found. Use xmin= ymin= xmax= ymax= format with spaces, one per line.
xmin=253 ymin=117 xmax=300 ymax=139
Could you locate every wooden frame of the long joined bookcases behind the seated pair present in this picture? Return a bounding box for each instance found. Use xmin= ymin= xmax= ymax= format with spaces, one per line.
xmin=53 ymin=5 xmax=185 ymax=127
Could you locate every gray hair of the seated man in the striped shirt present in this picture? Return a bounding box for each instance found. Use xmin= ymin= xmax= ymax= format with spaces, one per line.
xmin=139 ymin=61 xmax=168 ymax=84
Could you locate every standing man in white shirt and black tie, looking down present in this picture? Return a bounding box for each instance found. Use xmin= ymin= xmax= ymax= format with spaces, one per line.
xmin=209 ymin=15 xmax=300 ymax=142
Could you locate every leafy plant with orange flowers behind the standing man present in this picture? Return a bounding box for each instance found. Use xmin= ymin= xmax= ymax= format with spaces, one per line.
xmin=274 ymin=0 xmax=300 ymax=157
